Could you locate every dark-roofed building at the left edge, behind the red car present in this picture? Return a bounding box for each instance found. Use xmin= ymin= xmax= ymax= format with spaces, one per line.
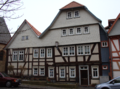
xmin=0 ymin=17 xmax=11 ymax=72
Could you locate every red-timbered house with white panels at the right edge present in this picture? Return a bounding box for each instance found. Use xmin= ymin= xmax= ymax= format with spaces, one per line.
xmin=106 ymin=14 xmax=120 ymax=78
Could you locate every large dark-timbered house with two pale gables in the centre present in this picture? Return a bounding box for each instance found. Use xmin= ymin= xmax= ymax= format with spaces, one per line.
xmin=5 ymin=1 xmax=108 ymax=85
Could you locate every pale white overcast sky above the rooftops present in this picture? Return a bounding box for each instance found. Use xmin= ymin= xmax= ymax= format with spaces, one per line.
xmin=5 ymin=0 xmax=120 ymax=33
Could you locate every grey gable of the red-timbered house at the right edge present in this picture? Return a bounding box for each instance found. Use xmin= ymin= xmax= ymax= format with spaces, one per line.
xmin=109 ymin=19 xmax=120 ymax=36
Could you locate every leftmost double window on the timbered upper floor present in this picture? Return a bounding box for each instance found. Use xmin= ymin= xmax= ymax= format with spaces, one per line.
xmin=12 ymin=50 xmax=24 ymax=61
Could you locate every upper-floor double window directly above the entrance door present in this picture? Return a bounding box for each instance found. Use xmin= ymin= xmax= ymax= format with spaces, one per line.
xmin=77 ymin=45 xmax=91 ymax=55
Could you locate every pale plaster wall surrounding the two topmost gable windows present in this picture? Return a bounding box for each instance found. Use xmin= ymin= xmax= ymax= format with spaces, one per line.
xmin=51 ymin=9 xmax=98 ymax=28
